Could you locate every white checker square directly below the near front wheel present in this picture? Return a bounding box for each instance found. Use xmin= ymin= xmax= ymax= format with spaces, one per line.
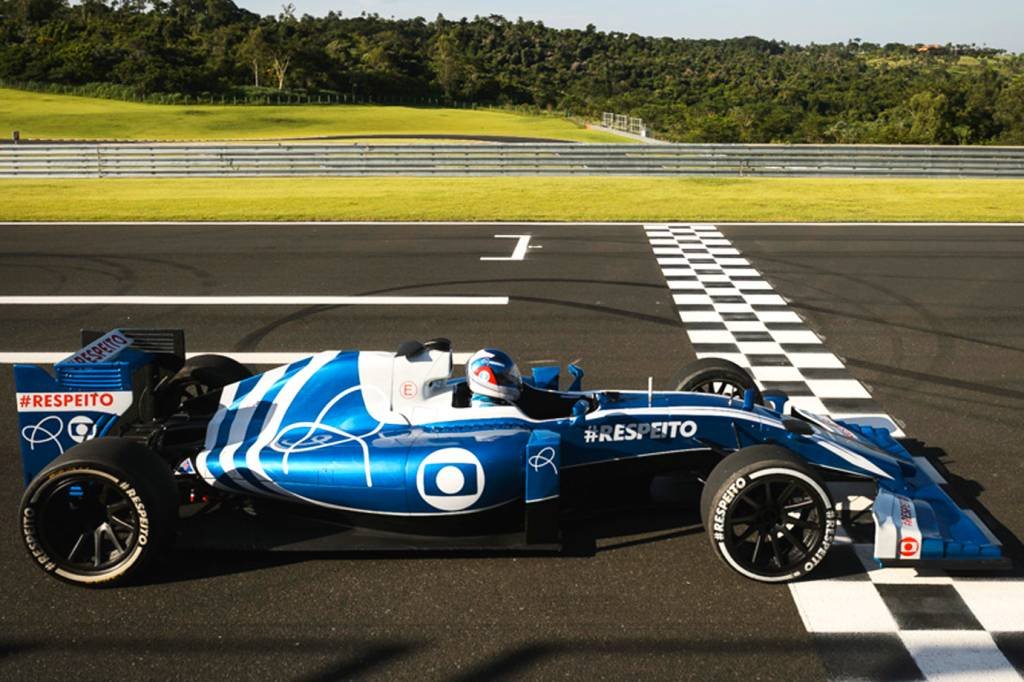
xmin=790 ymin=581 xmax=897 ymax=633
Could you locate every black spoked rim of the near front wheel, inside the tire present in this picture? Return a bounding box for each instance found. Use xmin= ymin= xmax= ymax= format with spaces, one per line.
xmin=725 ymin=475 xmax=826 ymax=578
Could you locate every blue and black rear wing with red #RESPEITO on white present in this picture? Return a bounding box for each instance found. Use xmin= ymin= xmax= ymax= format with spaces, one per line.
xmin=14 ymin=329 xmax=185 ymax=484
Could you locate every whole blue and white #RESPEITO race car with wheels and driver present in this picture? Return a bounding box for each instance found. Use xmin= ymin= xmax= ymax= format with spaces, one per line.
xmin=14 ymin=329 xmax=1006 ymax=586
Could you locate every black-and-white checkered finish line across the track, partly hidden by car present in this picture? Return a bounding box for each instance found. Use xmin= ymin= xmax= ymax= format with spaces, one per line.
xmin=645 ymin=224 xmax=1024 ymax=680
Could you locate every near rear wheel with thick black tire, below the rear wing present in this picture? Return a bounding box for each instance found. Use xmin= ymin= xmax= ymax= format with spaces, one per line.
xmin=20 ymin=438 xmax=178 ymax=587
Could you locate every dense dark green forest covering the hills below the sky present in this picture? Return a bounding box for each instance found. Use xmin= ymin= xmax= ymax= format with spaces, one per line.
xmin=0 ymin=0 xmax=1024 ymax=144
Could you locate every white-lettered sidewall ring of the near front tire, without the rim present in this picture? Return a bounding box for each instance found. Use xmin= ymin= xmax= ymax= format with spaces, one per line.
xmin=703 ymin=458 xmax=837 ymax=583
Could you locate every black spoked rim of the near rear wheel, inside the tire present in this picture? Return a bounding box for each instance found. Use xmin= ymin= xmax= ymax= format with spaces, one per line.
xmin=36 ymin=475 xmax=139 ymax=574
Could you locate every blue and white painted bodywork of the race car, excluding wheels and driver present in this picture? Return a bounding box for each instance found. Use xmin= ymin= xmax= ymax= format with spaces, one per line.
xmin=15 ymin=339 xmax=1000 ymax=561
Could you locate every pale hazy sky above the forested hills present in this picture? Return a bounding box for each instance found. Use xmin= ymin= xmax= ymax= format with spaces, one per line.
xmin=236 ymin=0 xmax=1024 ymax=52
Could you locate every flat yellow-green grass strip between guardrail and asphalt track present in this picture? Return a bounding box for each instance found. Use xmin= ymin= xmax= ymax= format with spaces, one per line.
xmin=0 ymin=177 xmax=1024 ymax=222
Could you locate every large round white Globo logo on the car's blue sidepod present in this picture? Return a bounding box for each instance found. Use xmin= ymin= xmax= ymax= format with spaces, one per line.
xmin=416 ymin=447 xmax=484 ymax=511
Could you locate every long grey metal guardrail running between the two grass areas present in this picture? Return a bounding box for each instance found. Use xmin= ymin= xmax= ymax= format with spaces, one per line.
xmin=0 ymin=143 xmax=1024 ymax=178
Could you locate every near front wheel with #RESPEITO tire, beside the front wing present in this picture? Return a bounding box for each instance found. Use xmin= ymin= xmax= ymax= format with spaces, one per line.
xmin=700 ymin=445 xmax=836 ymax=583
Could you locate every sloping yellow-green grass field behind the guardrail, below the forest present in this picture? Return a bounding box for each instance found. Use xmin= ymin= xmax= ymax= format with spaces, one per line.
xmin=0 ymin=89 xmax=624 ymax=142
